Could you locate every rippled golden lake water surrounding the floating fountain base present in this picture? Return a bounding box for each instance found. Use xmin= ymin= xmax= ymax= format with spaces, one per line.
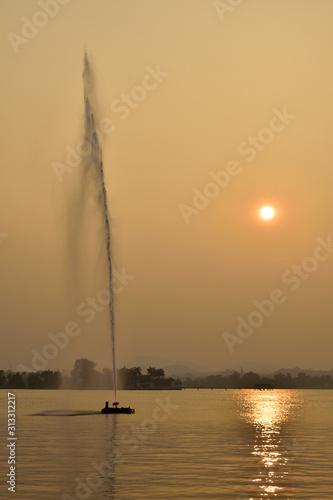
xmin=0 ymin=389 xmax=333 ymax=500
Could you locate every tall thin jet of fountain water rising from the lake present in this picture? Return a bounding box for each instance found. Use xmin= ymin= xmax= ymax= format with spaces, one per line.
xmin=83 ymin=52 xmax=117 ymax=401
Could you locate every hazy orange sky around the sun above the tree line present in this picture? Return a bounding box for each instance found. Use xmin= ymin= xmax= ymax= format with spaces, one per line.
xmin=0 ymin=0 xmax=333 ymax=370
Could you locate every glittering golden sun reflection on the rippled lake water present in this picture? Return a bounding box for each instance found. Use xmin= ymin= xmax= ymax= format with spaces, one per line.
xmin=237 ymin=390 xmax=301 ymax=499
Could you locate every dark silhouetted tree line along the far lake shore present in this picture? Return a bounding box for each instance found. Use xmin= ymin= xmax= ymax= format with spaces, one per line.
xmin=0 ymin=364 xmax=333 ymax=390
